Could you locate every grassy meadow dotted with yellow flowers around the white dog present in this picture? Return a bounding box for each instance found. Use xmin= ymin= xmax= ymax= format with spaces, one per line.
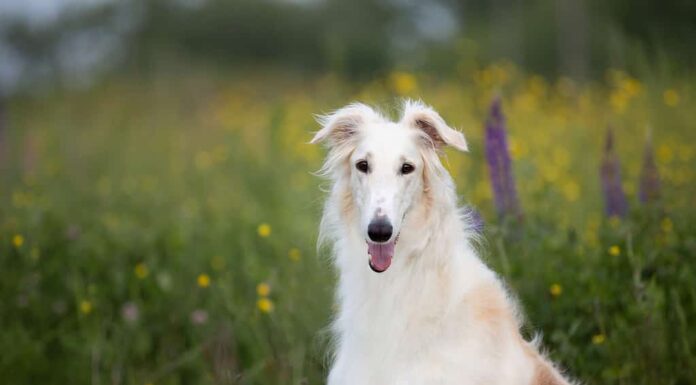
xmin=0 ymin=63 xmax=696 ymax=384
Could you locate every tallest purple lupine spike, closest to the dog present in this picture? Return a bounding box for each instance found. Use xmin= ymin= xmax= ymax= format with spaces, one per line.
xmin=486 ymin=97 xmax=521 ymax=217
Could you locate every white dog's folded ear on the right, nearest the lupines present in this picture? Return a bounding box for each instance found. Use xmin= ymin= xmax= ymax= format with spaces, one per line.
xmin=401 ymin=100 xmax=469 ymax=151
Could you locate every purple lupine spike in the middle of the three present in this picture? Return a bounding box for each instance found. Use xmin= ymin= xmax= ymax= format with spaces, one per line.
xmin=600 ymin=128 xmax=628 ymax=218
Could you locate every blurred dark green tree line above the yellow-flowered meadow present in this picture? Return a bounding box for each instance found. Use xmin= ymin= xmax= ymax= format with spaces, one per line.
xmin=0 ymin=0 xmax=696 ymax=95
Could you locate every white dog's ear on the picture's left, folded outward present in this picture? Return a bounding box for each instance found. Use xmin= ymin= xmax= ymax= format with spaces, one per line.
xmin=310 ymin=103 xmax=379 ymax=147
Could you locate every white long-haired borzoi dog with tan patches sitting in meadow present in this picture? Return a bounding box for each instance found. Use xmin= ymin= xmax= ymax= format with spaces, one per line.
xmin=312 ymin=102 xmax=568 ymax=385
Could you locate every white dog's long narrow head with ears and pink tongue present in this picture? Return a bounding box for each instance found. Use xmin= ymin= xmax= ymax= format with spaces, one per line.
xmin=311 ymin=101 xmax=467 ymax=273
